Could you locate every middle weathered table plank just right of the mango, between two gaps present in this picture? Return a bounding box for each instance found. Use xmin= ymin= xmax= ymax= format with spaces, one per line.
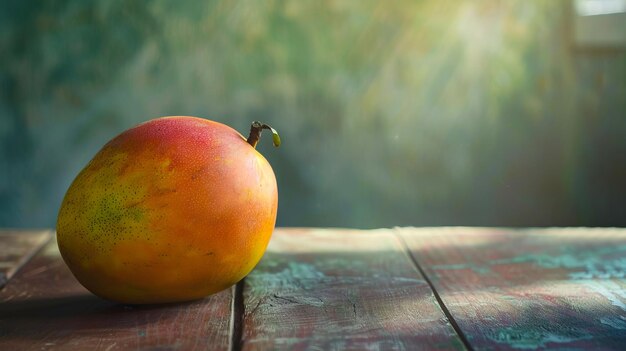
xmin=240 ymin=229 xmax=464 ymax=350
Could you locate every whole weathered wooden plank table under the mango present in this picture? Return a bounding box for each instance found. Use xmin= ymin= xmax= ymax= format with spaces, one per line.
xmin=0 ymin=228 xmax=626 ymax=351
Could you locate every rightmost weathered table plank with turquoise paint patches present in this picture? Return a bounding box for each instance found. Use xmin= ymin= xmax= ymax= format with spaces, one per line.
xmin=398 ymin=228 xmax=626 ymax=350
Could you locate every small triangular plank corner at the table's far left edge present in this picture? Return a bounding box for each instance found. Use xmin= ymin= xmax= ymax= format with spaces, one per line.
xmin=0 ymin=230 xmax=52 ymax=290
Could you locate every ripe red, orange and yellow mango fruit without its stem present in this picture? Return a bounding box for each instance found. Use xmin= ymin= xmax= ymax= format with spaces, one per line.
xmin=57 ymin=116 xmax=278 ymax=304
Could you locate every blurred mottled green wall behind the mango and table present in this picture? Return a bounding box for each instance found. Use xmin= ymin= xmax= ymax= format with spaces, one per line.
xmin=0 ymin=0 xmax=626 ymax=228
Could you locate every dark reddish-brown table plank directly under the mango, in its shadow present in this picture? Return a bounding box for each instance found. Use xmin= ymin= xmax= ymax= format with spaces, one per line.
xmin=0 ymin=236 xmax=232 ymax=351
